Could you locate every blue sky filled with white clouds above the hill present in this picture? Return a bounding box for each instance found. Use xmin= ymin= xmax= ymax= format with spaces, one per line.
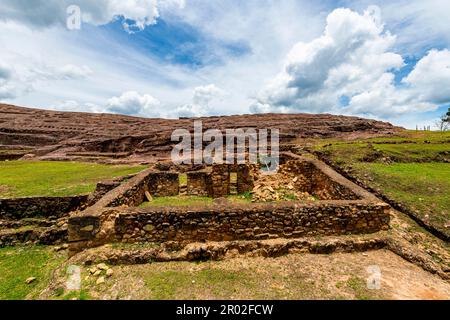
xmin=0 ymin=0 xmax=450 ymax=128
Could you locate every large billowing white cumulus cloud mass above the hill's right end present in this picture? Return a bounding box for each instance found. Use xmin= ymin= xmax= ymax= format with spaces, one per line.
xmin=251 ymin=7 xmax=450 ymax=117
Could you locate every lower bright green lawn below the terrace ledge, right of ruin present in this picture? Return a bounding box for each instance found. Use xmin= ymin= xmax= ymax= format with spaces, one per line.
xmin=354 ymin=163 xmax=450 ymax=229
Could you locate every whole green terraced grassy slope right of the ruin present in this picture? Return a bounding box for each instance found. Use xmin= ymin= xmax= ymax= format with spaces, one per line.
xmin=313 ymin=131 xmax=450 ymax=234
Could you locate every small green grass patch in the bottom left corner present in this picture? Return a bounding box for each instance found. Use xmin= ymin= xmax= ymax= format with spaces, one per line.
xmin=0 ymin=247 xmax=65 ymax=300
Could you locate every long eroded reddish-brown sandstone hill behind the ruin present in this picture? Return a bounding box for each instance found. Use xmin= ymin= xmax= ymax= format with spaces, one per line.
xmin=0 ymin=104 xmax=400 ymax=162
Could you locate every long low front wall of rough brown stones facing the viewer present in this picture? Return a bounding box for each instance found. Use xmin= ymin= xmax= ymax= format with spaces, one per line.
xmin=69 ymin=201 xmax=390 ymax=248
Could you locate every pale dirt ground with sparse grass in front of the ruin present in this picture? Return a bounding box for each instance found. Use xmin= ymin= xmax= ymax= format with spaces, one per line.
xmin=47 ymin=250 xmax=450 ymax=300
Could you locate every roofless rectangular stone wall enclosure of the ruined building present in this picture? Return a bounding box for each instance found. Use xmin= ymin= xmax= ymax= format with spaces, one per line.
xmin=69 ymin=156 xmax=390 ymax=252
